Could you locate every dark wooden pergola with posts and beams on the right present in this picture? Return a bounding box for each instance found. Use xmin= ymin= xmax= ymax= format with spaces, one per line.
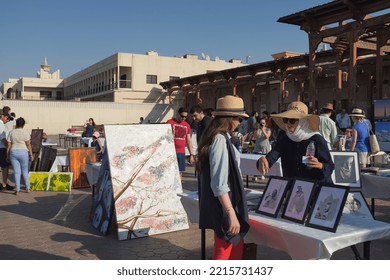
xmin=160 ymin=0 xmax=390 ymax=114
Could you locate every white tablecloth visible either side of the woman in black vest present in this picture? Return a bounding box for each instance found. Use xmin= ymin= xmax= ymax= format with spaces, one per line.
xmin=178 ymin=189 xmax=263 ymax=224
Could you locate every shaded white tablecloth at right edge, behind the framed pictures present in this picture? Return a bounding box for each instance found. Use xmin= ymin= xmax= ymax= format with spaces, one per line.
xmin=361 ymin=174 xmax=390 ymax=199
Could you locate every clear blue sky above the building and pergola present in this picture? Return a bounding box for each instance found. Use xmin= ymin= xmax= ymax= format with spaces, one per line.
xmin=0 ymin=0 xmax=330 ymax=84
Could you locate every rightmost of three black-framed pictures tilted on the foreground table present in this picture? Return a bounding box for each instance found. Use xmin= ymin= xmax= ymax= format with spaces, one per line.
xmin=306 ymin=184 xmax=349 ymax=232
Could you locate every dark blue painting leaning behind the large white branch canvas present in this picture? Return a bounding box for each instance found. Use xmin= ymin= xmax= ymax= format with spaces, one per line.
xmin=90 ymin=153 xmax=114 ymax=235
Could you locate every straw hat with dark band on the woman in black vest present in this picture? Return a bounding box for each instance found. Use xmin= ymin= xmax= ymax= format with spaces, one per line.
xmin=212 ymin=95 xmax=249 ymax=118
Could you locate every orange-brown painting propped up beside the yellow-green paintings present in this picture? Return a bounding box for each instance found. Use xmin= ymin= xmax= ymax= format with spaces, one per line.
xmin=68 ymin=148 xmax=96 ymax=188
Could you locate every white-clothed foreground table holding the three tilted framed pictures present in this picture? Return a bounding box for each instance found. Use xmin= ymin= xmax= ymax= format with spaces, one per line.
xmin=245 ymin=212 xmax=390 ymax=259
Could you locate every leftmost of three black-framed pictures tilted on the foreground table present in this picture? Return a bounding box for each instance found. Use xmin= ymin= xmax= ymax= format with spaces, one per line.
xmin=256 ymin=176 xmax=290 ymax=217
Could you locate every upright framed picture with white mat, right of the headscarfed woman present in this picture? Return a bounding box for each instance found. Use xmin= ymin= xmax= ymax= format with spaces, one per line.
xmin=330 ymin=152 xmax=362 ymax=188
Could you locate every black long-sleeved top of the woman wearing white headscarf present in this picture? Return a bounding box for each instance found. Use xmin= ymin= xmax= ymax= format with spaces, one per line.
xmin=266 ymin=134 xmax=334 ymax=183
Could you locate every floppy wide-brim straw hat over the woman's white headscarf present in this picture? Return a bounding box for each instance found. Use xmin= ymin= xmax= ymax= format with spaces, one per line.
xmin=271 ymin=101 xmax=320 ymax=131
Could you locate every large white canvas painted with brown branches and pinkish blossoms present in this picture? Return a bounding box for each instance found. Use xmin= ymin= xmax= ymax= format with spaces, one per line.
xmin=105 ymin=124 xmax=189 ymax=240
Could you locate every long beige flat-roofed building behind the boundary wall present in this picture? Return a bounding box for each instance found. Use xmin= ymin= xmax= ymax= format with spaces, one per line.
xmin=1 ymin=51 xmax=243 ymax=104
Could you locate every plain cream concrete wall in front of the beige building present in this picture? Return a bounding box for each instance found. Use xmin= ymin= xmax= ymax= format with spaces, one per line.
xmin=0 ymin=100 xmax=175 ymax=135
